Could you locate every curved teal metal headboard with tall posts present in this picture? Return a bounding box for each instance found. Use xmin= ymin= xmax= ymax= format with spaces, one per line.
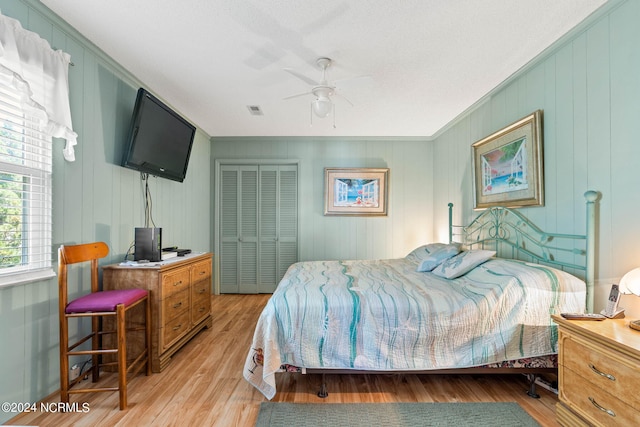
xmin=449 ymin=191 xmax=598 ymax=313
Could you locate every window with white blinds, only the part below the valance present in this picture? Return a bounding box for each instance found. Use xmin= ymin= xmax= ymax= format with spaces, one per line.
xmin=0 ymin=79 xmax=53 ymax=286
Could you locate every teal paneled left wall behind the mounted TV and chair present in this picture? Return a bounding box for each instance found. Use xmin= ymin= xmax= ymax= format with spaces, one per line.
xmin=0 ymin=0 xmax=212 ymax=422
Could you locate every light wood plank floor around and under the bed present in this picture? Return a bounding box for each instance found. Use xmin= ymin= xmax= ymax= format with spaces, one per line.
xmin=8 ymin=295 xmax=558 ymax=427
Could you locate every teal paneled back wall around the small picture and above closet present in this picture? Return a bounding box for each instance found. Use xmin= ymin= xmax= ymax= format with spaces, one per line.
xmin=212 ymin=137 xmax=432 ymax=260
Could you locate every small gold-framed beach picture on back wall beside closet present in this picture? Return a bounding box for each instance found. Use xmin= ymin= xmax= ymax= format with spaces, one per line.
xmin=324 ymin=168 xmax=389 ymax=216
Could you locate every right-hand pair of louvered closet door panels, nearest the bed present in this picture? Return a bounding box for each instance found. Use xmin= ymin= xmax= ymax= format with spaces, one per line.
xmin=258 ymin=165 xmax=298 ymax=293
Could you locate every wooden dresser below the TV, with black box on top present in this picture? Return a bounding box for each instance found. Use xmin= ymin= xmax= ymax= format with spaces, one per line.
xmin=102 ymin=253 xmax=212 ymax=372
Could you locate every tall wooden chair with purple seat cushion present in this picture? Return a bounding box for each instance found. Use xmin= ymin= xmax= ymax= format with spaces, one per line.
xmin=58 ymin=242 xmax=151 ymax=410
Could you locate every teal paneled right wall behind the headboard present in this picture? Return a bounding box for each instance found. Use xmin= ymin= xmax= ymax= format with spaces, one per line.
xmin=433 ymin=0 xmax=640 ymax=316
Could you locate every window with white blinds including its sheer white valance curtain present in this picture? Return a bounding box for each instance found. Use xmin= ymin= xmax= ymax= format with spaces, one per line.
xmin=0 ymin=14 xmax=78 ymax=287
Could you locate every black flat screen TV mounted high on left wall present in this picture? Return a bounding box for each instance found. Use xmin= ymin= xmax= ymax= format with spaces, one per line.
xmin=122 ymin=88 xmax=196 ymax=182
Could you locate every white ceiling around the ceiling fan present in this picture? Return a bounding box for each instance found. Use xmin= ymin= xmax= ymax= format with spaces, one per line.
xmin=41 ymin=0 xmax=606 ymax=137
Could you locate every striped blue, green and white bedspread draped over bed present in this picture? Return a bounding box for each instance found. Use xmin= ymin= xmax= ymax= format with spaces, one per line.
xmin=244 ymin=257 xmax=586 ymax=399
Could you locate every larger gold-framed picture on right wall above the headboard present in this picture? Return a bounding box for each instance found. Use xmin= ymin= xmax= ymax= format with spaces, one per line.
xmin=472 ymin=110 xmax=544 ymax=209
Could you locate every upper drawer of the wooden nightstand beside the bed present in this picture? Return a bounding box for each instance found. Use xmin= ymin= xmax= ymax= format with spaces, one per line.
xmin=559 ymin=335 xmax=640 ymax=407
